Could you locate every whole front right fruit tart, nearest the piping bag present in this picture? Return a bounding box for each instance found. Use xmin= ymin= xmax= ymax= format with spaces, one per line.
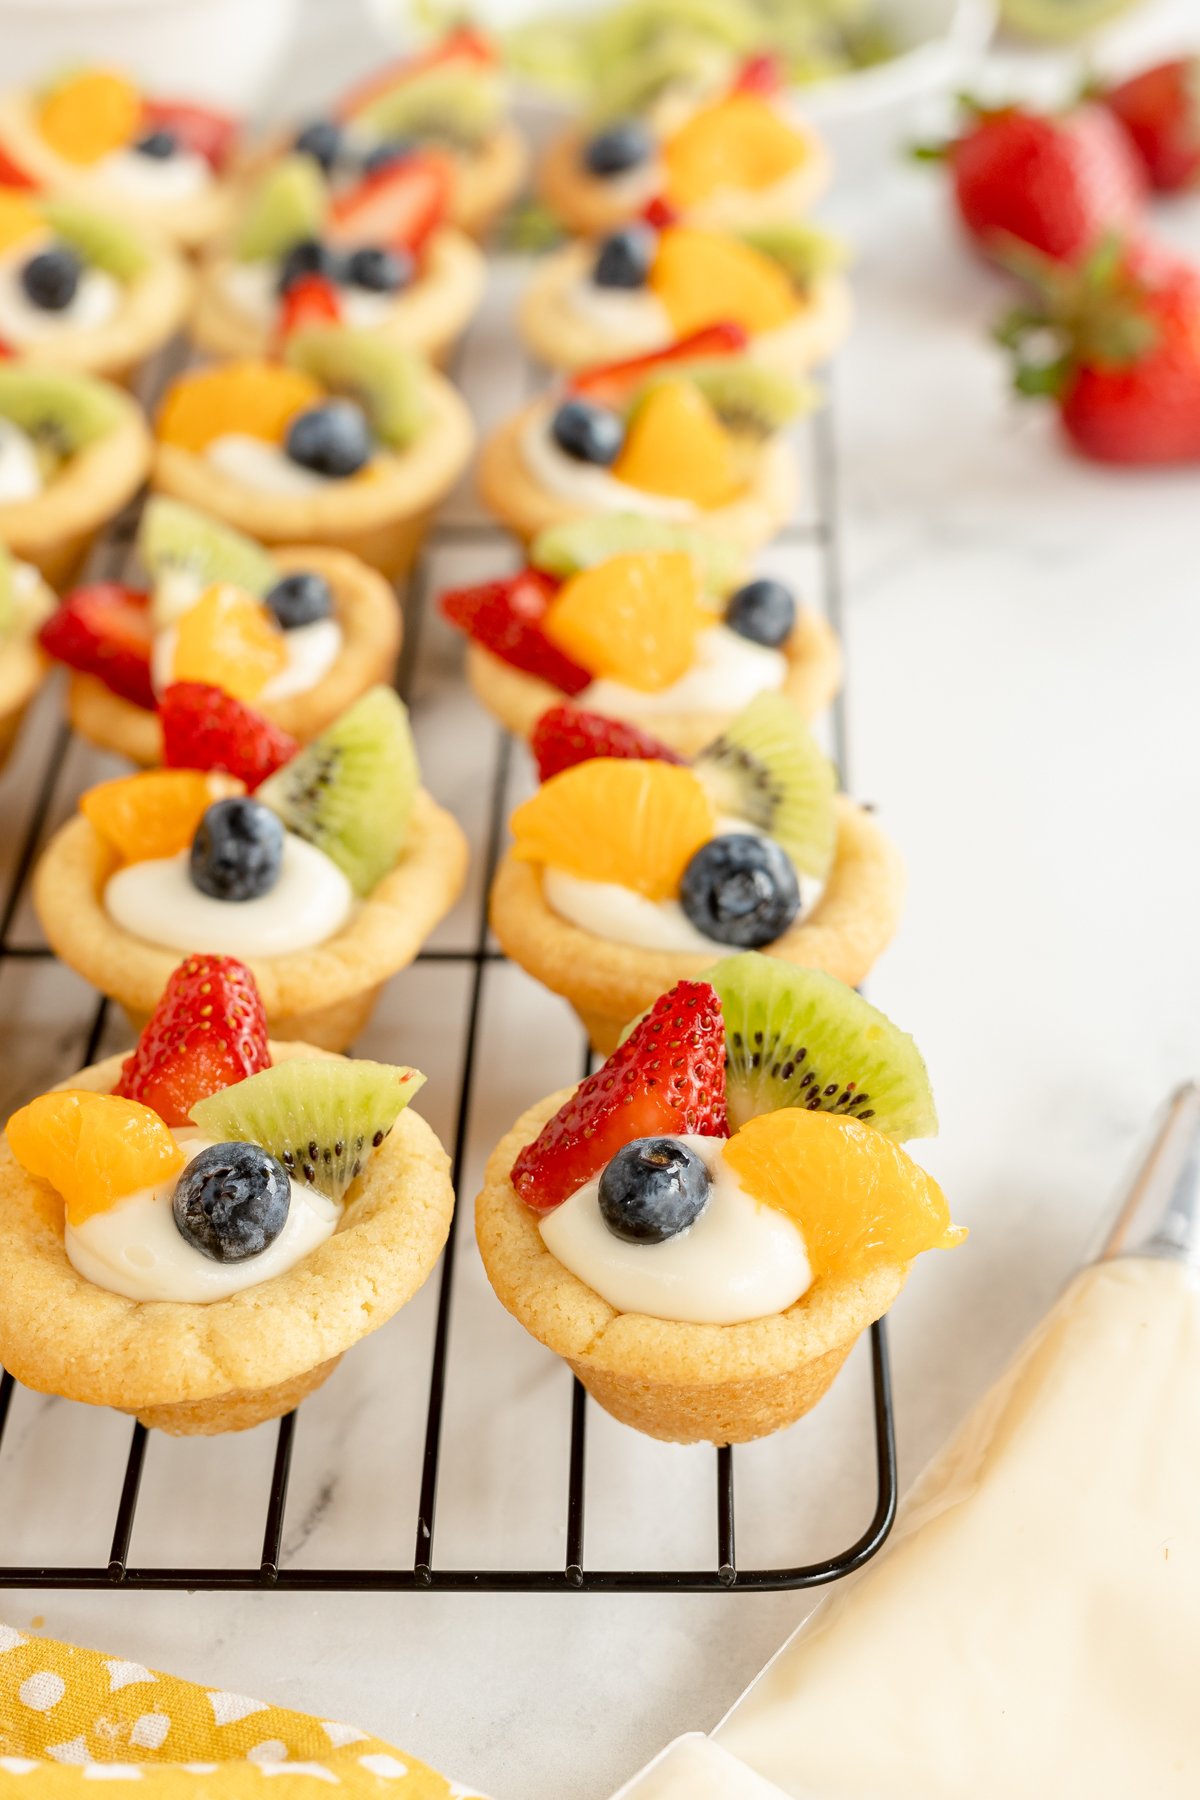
xmin=475 ymin=954 xmax=966 ymax=1444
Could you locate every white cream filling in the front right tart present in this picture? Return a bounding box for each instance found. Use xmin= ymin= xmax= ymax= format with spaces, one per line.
xmin=538 ymin=1138 xmax=813 ymax=1325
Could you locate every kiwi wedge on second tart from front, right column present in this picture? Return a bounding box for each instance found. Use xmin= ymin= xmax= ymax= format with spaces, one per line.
xmin=693 ymin=693 xmax=837 ymax=880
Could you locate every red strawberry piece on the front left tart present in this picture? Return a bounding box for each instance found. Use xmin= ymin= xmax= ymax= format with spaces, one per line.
xmin=113 ymin=956 xmax=272 ymax=1125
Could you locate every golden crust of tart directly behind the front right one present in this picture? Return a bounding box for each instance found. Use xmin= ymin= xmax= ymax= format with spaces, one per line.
xmin=491 ymin=794 xmax=905 ymax=1057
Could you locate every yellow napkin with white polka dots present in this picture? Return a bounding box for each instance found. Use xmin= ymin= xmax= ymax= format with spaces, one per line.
xmin=0 ymin=1625 xmax=482 ymax=1800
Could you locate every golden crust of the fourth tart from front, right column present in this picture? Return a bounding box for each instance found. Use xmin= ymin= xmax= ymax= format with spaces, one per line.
xmin=477 ymin=400 xmax=799 ymax=551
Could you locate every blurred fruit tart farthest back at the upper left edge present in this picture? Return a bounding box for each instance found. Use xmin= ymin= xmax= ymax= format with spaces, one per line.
xmin=0 ymin=65 xmax=237 ymax=250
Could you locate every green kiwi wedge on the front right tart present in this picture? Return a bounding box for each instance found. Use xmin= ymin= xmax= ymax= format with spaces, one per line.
xmin=705 ymin=950 xmax=937 ymax=1138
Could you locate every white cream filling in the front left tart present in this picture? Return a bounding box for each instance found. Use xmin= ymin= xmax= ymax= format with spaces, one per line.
xmin=65 ymin=1130 xmax=340 ymax=1303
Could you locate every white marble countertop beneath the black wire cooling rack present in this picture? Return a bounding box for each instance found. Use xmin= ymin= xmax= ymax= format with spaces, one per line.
xmin=0 ymin=3 xmax=1200 ymax=1800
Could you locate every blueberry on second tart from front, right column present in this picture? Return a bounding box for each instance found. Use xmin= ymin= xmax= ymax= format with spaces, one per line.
xmin=680 ymin=832 xmax=801 ymax=950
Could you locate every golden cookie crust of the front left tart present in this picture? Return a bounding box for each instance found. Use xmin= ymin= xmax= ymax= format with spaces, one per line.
xmin=0 ymin=1044 xmax=453 ymax=1431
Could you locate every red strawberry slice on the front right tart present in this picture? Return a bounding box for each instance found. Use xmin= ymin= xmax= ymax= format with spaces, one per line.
xmin=513 ymin=981 xmax=729 ymax=1213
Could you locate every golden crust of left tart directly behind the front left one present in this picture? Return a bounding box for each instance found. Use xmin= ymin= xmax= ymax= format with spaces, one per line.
xmin=32 ymin=790 xmax=468 ymax=1049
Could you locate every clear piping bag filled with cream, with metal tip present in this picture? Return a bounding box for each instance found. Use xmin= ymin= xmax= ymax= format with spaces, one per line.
xmin=613 ymin=1082 xmax=1200 ymax=1800
